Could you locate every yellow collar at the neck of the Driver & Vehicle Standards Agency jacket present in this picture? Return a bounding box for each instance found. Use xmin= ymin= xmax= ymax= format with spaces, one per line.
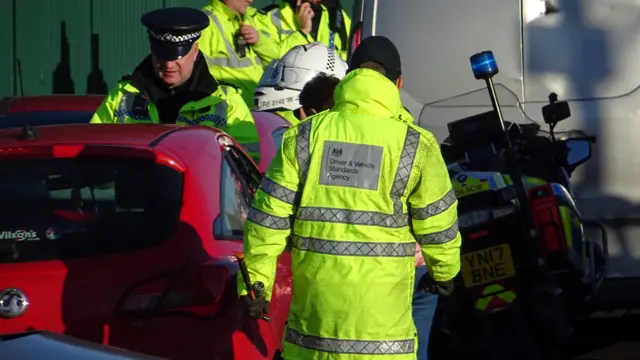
xmin=333 ymin=69 xmax=402 ymax=118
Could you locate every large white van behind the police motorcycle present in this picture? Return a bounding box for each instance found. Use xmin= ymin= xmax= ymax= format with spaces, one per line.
xmin=352 ymin=0 xmax=640 ymax=304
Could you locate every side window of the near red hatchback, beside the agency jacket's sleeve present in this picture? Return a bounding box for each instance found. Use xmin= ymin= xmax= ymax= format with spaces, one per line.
xmin=214 ymin=143 xmax=262 ymax=240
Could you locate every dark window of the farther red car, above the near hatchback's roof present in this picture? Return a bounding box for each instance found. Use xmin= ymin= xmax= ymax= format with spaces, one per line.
xmin=0 ymin=111 xmax=93 ymax=129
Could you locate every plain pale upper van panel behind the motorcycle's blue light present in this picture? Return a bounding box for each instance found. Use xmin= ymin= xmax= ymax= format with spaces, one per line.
xmin=372 ymin=0 xmax=523 ymax=104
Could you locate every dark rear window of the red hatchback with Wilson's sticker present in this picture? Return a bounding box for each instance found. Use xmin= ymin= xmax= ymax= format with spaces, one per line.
xmin=0 ymin=158 xmax=183 ymax=263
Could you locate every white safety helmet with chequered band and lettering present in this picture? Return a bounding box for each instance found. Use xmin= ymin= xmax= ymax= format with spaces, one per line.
xmin=253 ymin=42 xmax=348 ymax=111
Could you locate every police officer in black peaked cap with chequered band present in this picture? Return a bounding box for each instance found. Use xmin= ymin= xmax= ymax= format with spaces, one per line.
xmin=91 ymin=7 xmax=259 ymax=160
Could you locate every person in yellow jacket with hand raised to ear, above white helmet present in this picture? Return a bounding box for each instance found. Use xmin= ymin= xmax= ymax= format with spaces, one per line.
xmin=257 ymin=0 xmax=351 ymax=61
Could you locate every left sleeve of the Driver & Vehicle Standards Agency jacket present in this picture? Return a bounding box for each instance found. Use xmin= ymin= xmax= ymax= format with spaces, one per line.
xmin=238 ymin=127 xmax=300 ymax=300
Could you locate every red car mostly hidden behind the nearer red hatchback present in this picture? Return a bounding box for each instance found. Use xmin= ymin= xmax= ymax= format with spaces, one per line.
xmin=0 ymin=95 xmax=290 ymax=172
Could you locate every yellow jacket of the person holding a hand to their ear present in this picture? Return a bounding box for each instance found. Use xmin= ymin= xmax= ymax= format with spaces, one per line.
xmin=256 ymin=2 xmax=351 ymax=61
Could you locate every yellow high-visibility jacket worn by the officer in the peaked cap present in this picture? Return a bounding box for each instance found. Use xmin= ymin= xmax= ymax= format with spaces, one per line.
xmin=91 ymin=75 xmax=260 ymax=162
